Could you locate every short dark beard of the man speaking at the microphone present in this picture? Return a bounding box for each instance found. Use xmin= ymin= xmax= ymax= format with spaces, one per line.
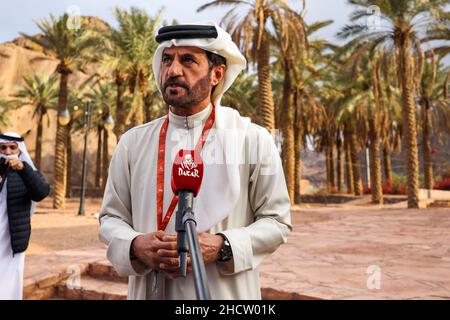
xmin=163 ymin=72 xmax=211 ymax=108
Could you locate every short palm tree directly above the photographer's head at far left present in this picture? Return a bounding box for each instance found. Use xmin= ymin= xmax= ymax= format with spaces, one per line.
xmin=14 ymin=74 xmax=58 ymax=169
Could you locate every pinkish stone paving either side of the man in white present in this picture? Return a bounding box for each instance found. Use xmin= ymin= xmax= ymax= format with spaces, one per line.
xmin=25 ymin=198 xmax=450 ymax=299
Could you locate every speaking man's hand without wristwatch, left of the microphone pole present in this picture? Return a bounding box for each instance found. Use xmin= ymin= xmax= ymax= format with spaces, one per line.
xmin=131 ymin=230 xmax=190 ymax=278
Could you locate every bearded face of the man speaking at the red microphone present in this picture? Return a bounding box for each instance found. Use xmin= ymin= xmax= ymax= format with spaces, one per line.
xmin=161 ymin=46 xmax=224 ymax=108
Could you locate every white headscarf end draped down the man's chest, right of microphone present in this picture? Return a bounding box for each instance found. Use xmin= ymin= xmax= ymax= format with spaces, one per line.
xmin=154 ymin=106 xmax=250 ymax=232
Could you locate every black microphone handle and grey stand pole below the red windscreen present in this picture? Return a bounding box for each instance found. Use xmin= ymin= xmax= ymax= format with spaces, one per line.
xmin=175 ymin=190 xmax=211 ymax=300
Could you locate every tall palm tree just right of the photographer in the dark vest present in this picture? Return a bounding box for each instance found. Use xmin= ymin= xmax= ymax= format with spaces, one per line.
xmin=22 ymin=14 xmax=98 ymax=209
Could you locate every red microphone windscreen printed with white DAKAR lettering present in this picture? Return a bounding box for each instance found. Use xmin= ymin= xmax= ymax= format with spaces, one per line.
xmin=171 ymin=149 xmax=203 ymax=197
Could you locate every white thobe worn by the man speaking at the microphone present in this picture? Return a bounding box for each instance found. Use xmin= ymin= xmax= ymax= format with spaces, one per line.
xmin=100 ymin=106 xmax=291 ymax=299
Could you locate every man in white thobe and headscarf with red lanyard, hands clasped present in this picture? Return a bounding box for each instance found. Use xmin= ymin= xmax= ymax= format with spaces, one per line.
xmin=99 ymin=22 xmax=291 ymax=299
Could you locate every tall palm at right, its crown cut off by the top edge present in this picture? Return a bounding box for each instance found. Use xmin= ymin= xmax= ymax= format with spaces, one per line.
xmin=338 ymin=0 xmax=449 ymax=208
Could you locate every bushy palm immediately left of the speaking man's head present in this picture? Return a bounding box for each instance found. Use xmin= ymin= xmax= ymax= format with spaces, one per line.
xmin=103 ymin=8 xmax=161 ymax=139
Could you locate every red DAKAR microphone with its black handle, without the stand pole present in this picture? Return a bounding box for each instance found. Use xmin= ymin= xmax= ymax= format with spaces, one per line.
xmin=171 ymin=149 xmax=203 ymax=277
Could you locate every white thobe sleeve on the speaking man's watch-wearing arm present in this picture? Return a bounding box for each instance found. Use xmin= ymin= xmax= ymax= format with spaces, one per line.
xmin=217 ymin=129 xmax=292 ymax=275
